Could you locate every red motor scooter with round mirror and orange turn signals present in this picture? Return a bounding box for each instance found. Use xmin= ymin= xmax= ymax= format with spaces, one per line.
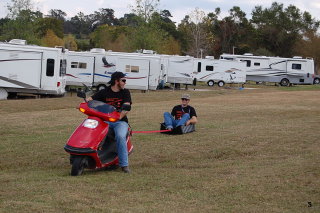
xmin=64 ymin=91 xmax=133 ymax=176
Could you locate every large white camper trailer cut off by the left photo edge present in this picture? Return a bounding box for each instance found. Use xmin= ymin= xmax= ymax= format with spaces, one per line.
xmin=0 ymin=39 xmax=66 ymax=99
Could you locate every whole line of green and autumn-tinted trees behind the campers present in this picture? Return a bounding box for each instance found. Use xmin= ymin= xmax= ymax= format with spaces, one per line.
xmin=0 ymin=0 xmax=320 ymax=71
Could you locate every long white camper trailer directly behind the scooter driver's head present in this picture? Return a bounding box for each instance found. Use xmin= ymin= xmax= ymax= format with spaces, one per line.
xmin=67 ymin=48 xmax=161 ymax=90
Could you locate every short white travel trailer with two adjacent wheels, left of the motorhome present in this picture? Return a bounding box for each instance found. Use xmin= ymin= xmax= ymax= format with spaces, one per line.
xmin=193 ymin=56 xmax=246 ymax=87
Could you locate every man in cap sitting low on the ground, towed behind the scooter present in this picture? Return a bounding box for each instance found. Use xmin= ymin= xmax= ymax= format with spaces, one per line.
xmin=163 ymin=94 xmax=198 ymax=130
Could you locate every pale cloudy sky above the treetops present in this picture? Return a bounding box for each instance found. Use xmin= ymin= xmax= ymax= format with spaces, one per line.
xmin=0 ymin=0 xmax=320 ymax=23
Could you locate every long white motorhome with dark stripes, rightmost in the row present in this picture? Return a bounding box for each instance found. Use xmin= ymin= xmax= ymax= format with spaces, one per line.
xmin=220 ymin=54 xmax=314 ymax=86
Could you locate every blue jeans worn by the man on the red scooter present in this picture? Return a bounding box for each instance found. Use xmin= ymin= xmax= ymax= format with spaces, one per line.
xmin=107 ymin=121 xmax=129 ymax=167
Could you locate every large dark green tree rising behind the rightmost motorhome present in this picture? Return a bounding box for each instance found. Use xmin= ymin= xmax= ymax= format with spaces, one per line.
xmin=251 ymin=2 xmax=319 ymax=57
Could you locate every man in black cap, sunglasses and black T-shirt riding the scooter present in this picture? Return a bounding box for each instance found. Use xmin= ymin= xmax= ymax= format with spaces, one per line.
xmin=86 ymin=72 xmax=132 ymax=173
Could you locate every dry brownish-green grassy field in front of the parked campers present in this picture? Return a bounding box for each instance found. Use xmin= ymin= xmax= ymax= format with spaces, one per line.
xmin=0 ymin=85 xmax=320 ymax=213
